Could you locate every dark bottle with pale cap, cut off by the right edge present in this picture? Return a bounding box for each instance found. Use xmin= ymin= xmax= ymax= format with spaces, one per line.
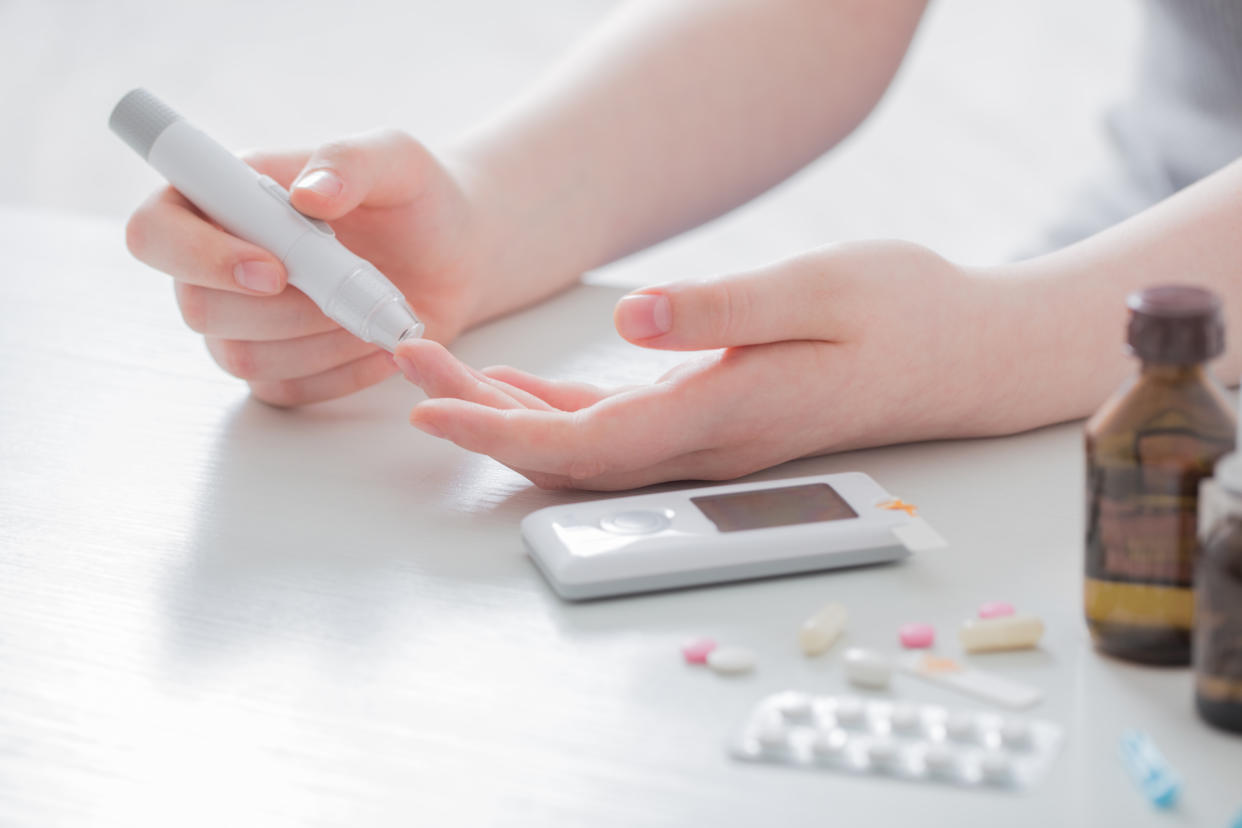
xmin=1195 ymin=407 xmax=1242 ymax=732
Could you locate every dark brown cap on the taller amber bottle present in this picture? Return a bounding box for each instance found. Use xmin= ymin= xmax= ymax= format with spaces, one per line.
xmin=1125 ymin=284 xmax=1225 ymax=365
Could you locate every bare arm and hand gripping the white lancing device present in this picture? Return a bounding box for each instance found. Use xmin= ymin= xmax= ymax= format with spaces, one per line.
xmin=127 ymin=0 xmax=925 ymax=405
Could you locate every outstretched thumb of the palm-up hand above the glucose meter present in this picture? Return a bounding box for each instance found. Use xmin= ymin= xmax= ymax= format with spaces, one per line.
xmin=612 ymin=257 xmax=841 ymax=350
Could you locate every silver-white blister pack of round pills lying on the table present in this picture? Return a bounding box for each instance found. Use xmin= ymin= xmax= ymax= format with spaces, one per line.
xmin=729 ymin=690 xmax=1063 ymax=791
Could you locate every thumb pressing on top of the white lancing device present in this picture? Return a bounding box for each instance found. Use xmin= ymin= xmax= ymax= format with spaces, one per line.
xmin=289 ymin=129 xmax=436 ymax=221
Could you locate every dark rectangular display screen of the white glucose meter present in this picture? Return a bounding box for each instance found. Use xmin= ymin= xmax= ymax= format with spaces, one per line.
xmin=691 ymin=483 xmax=858 ymax=531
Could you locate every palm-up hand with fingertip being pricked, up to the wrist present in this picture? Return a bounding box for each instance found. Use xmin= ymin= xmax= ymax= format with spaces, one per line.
xmin=396 ymin=242 xmax=1020 ymax=489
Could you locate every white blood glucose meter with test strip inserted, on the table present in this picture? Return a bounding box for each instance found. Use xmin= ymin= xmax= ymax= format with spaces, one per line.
xmin=522 ymin=472 xmax=945 ymax=600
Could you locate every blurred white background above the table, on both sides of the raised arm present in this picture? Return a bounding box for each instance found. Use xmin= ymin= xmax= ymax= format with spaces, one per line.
xmin=0 ymin=0 xmax=1139 ymax=283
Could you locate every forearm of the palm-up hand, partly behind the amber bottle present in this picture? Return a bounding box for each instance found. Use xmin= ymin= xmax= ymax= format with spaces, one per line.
xmin=1001 ymin=152 xmax=1242 ymax=427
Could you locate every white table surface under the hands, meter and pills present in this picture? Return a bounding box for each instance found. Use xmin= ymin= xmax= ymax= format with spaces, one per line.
xmin=0 ymin=203 xmax=1242 ymax=827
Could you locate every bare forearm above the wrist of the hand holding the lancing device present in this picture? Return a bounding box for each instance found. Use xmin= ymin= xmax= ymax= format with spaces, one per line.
xmin=457 ymin=0 xmax=924 ymax=319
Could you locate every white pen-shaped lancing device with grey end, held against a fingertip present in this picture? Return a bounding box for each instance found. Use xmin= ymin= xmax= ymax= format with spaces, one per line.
xmin=108 ymin=89 xmax=424 ymax=351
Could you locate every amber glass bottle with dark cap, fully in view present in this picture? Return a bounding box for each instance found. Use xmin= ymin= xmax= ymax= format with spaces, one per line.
xmin=1083 ymin=286 xmax=1235 ymax=664
